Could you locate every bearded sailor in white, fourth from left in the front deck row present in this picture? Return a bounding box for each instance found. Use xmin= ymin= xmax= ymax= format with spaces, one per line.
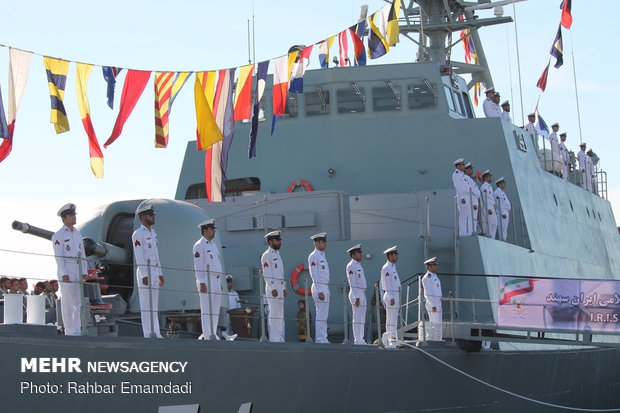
xmin=260 ymin=231 xmax=287 ymax=343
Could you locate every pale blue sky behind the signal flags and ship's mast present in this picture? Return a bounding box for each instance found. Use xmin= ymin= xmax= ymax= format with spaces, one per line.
xmin=0 ymin=0 xmax=620 ymax=279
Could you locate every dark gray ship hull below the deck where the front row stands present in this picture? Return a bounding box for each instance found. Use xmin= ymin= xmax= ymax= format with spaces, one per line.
xmin=6 ymin=326 xmax=620 ymax=413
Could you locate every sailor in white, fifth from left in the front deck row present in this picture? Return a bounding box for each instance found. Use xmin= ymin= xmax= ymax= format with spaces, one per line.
xmin=308 ymin=232 xmax=331 ymax=343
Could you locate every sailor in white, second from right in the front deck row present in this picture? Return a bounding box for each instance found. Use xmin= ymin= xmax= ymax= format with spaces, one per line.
xmin=381 ymin=245 xmax=401 ymax=345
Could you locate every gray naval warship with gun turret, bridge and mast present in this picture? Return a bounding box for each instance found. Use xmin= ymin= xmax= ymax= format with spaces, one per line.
xmin=0 ymin=0 xmax=620 ymax=413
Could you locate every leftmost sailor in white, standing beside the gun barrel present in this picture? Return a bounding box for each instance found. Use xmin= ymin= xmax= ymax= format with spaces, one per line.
xmin=52 ymin=204 xmax=87 ymax=336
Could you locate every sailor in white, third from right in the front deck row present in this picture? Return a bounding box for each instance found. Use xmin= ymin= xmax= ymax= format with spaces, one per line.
xmin=347 ymin=244 xmax=366 ymax=345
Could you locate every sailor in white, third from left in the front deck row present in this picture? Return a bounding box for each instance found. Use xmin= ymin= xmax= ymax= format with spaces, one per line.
xmin=192 ymin=219 xmax=223 ymax=340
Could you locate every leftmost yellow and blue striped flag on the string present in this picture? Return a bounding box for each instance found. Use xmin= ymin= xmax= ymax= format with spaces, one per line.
xmin=43 ymin=57 xmax=69 ymax=133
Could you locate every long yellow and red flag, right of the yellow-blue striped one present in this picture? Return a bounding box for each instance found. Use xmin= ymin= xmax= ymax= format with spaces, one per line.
xmin=75 ymin=63 xmax=103 ymax=179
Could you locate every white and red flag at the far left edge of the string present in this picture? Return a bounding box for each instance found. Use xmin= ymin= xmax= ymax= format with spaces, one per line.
xmin=0 ymin=48 xmax=32 ymax=162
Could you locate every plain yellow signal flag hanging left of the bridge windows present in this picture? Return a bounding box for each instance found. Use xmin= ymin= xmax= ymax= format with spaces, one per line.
xmin=194 ymin=72 xmax=224 ymax=151
